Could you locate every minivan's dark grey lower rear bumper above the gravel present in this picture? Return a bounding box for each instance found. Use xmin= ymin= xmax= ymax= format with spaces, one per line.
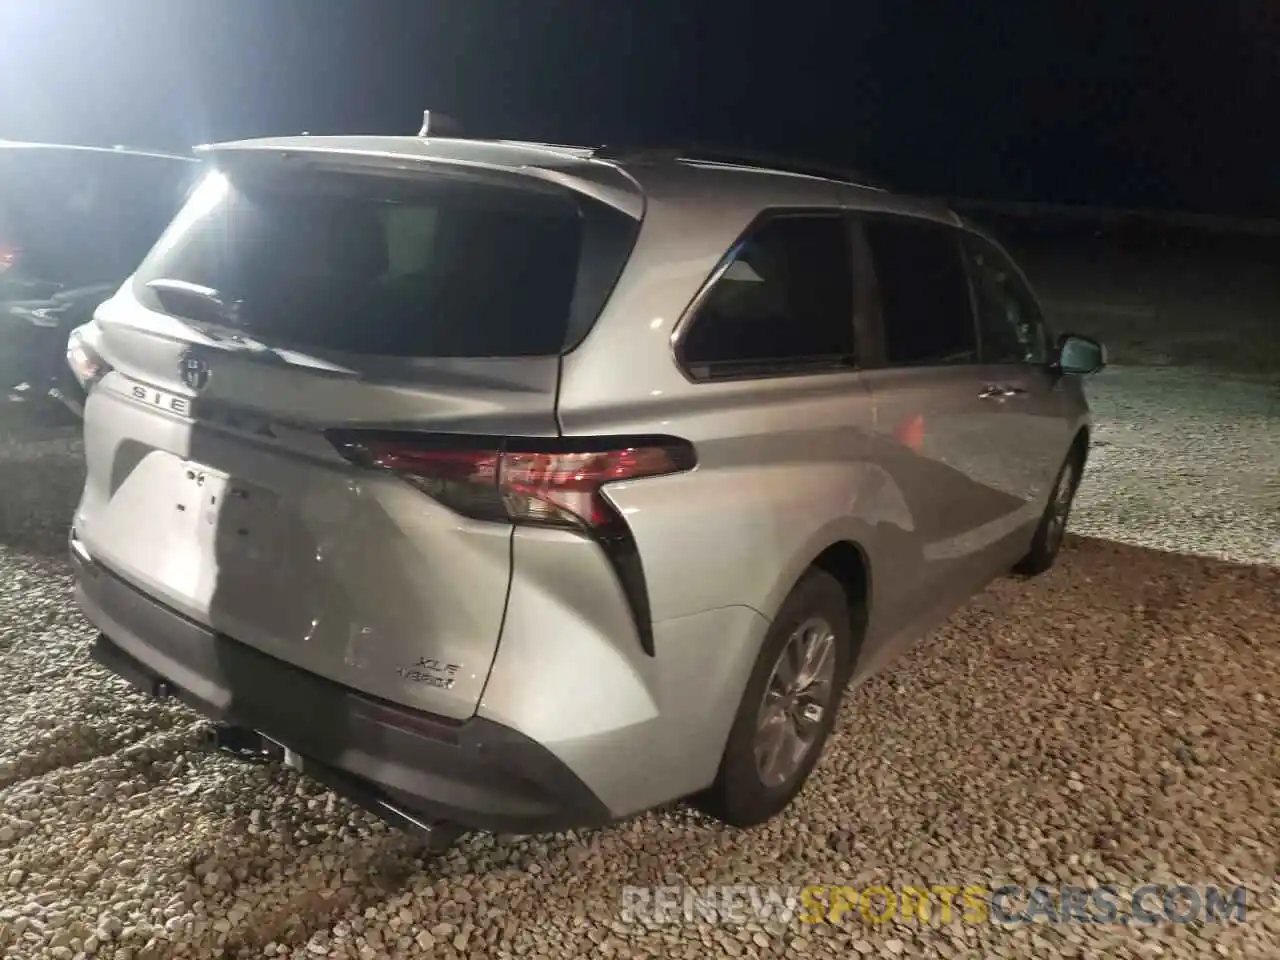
xmin=72 ymin=540 xmax=612 ymax=833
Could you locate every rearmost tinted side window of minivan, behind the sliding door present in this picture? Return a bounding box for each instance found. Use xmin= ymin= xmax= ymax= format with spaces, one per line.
xmin=680 ymin=215 xmax=854 ymax=379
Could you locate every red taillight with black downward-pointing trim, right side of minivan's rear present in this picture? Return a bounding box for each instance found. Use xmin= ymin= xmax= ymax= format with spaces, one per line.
xmin=328 ymin=430 xmax=696 ymax=655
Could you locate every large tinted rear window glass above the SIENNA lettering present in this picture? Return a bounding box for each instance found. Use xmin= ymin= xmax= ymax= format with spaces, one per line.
xmin=134 ymin=169 xmax=634 ymax=357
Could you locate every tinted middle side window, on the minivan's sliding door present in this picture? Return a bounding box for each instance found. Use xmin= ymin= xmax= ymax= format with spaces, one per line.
xmin=863 ymin=216 xmax=978 ymax=366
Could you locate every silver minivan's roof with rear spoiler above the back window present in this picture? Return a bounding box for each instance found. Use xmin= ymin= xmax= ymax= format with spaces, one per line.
xmin=196 ymin=134 xmax=956 ymax=224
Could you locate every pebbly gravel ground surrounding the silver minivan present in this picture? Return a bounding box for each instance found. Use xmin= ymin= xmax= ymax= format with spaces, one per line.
xmin=0 ymin=369 xmax=1280 ymax=960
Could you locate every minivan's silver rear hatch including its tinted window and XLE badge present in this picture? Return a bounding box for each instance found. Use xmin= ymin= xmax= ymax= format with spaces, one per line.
xmin=76 ymin=155 xmax=636 ymax=718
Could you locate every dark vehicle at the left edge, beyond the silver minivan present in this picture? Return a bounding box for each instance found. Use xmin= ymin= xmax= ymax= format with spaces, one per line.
xmin=0 ymin=141 xmax=198 ymax=408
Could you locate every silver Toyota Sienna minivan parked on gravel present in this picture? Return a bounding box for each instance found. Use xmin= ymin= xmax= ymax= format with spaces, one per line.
xmin=70 ymin=134 xmax=1105 ymax=833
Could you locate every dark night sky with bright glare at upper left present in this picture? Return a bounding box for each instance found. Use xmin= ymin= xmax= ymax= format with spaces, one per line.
xmin=0 ymin=0 xmax=1280 ymax=216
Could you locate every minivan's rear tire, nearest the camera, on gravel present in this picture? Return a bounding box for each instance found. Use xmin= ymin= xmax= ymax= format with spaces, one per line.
xmin=692 ymin=570 xmax=855 ymax=827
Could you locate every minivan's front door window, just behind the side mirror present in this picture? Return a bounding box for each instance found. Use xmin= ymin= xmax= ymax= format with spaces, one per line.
xmin=964 ymin=234 xmax=1050 ymax=364
